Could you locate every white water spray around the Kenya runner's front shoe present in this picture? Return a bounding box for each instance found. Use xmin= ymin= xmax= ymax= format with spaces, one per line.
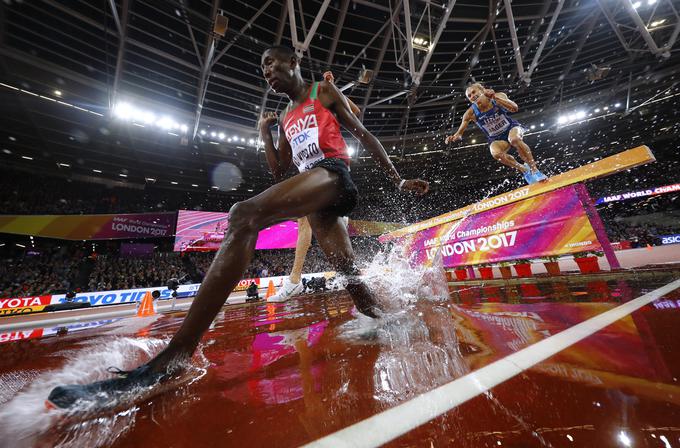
xmin=0 ymin=338 xmax=166 ymax=448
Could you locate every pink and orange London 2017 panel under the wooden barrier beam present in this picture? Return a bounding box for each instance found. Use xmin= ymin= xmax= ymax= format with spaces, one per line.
xmin=398 ymin=186 xmax=602 ymax=267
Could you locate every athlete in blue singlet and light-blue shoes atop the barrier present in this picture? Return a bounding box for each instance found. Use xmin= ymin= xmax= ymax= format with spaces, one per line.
xmin=446 ymin=83 xmax=547 ymax=184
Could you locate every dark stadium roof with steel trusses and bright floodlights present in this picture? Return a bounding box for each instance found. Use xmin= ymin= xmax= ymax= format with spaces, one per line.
xmin=0 ymin=0 xmax=680 ymax=200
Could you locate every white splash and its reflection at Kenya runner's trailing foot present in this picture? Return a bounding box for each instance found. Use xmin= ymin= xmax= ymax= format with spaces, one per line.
xmin=340 ymin=242 xmax=469 ymax=405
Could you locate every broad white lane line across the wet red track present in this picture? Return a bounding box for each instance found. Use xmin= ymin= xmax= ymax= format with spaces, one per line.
xmin=305 ymin=279 xmax=680 ymax=448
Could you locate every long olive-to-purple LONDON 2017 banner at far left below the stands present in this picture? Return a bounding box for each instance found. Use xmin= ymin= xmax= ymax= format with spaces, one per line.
xmin=0 ymin=212 xmax=176 ymax=240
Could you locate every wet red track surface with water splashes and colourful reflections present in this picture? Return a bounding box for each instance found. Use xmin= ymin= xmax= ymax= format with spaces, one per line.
xmin=0 ymin=264 xmax=680 ymax=448
